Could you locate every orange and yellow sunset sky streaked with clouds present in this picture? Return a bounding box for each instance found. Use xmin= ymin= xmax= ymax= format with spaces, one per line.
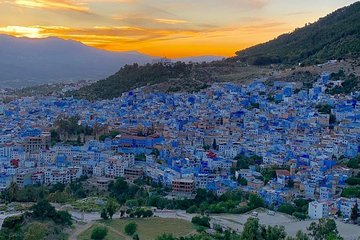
xmin=0 ymin=0 xmax=356 ymax=58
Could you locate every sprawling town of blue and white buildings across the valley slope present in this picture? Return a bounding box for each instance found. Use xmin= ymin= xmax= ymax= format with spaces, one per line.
xmin=0 ymin=71 xmax=360 ymax=227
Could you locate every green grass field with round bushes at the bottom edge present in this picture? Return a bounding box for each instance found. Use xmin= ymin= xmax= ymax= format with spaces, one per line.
xmin=78 ymin=218 xmax=195 ymax=240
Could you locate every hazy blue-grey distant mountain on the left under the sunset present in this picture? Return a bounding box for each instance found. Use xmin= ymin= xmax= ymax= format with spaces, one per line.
xmin=0 ymin=35 xmax=152 ymax=88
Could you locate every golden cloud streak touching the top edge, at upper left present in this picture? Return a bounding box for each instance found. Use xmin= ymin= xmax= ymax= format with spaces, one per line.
xmin=14 ymin=0 xmax=90 ymax=13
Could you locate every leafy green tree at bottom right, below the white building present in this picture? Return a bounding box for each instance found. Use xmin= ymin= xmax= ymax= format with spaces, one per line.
xmin=308 ymin=219 xmax=338 ymax=240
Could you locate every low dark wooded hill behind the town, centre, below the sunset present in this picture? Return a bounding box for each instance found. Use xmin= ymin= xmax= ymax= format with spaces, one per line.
xmin=68 ymin=61 xmax=270 ymax=100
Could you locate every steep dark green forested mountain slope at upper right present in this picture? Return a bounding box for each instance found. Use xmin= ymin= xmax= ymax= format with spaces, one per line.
xmin=232 ymin=2 xmax=360 ymax=65
